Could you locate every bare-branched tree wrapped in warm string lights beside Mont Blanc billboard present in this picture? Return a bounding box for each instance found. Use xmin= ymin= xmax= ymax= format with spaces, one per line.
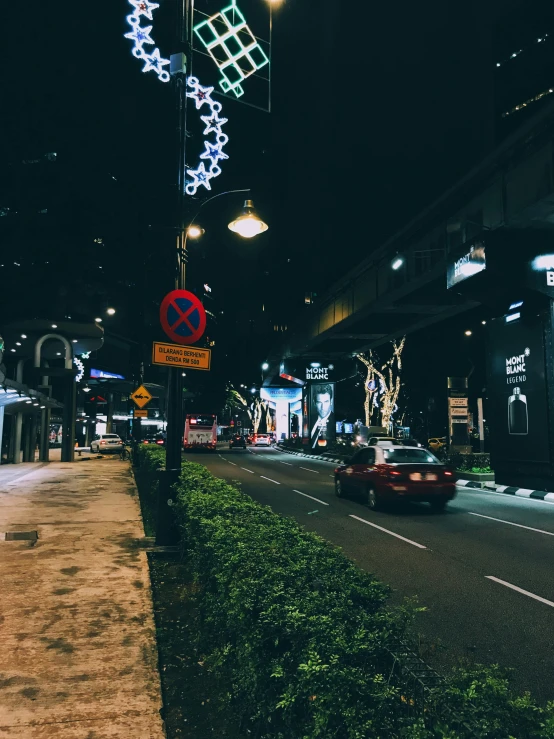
xmin=356 ymin=336 xmax=406 ymax=429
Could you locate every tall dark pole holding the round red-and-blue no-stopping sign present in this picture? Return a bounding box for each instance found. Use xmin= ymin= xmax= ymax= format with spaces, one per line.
xmin=156 ymin=0 xmax=190 ymax=546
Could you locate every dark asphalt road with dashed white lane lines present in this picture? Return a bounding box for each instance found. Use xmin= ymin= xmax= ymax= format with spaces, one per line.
xmin=186 ymin=447 xmax=554 ymax=700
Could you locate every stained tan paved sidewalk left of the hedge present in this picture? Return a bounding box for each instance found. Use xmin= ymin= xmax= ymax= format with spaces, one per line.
xmin=0 ymin=458 xmax=164 ymax=739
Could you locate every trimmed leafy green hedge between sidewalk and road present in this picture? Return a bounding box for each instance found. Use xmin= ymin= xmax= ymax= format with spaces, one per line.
xmin=137 ymin=450 xmax=554 ymax=739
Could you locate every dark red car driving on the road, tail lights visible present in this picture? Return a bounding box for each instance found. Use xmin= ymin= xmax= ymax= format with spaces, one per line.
xmin=335 ymin=446 xmax=456 ymax=510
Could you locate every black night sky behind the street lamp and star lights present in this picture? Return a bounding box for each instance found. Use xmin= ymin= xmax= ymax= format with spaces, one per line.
xmin=0 ymin=0 xmax=528 ymax=424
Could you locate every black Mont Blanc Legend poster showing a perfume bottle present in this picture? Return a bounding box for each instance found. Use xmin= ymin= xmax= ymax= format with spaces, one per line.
xmin=487 ymin=316 xmax=549 ymax=462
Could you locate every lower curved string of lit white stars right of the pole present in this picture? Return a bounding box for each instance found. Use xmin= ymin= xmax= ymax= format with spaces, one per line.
xmin=185 ymin=77 xmax=229 ymax=195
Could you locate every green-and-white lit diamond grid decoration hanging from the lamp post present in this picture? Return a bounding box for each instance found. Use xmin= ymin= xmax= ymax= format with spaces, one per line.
xmin=194 ymin=0 xmax=269 ymax=98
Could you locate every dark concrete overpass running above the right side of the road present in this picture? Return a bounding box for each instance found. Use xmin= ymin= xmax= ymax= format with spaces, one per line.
xmin=281 ymin=105 xmax=554 ymax=358
